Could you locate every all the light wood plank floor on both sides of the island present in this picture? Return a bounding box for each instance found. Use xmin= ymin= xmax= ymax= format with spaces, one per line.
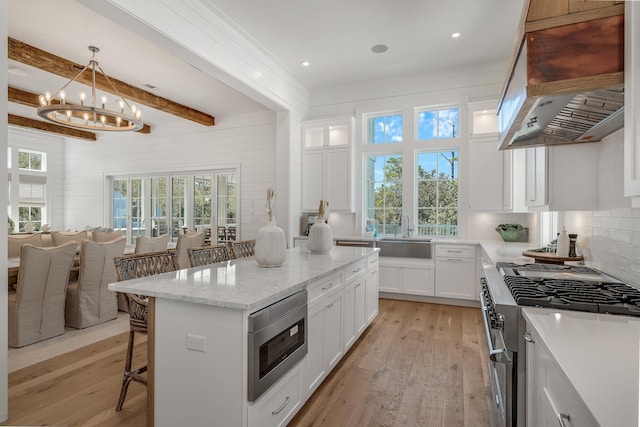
xmin=1 ymin=300 xmax=489 ymax=427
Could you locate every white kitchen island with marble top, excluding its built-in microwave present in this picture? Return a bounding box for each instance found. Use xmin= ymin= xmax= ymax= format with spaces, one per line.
xmin=109 ymin=247 xmax=378 ymax=427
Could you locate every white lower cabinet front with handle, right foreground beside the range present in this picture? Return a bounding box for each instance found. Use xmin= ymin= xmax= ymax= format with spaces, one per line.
xmin=525 ymin=323 xmax=598 ymax=427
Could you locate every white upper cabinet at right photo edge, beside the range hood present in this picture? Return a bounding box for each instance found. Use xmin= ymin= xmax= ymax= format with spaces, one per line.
xmin=624 ymin=1 xmax=640 ymax=206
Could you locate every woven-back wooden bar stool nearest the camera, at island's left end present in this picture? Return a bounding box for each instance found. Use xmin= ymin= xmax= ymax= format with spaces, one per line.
xmin=114 ymin=251 xmax=176 ymax=411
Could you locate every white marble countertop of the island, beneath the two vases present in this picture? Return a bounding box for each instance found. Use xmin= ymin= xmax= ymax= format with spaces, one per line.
xmin=109 ymin=247 xmax=379 ymax=310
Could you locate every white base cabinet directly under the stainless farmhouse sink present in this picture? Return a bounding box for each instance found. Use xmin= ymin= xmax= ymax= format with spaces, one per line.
xmin=378 ymin=257 xmax=434 ymax=296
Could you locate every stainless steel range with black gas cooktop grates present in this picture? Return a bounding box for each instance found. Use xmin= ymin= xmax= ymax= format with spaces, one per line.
xmin=480 ymin=263 xmax=640 ymax=427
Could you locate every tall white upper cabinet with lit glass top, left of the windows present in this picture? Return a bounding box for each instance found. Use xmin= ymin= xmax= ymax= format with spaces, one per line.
xmin=302 ymin=118 xmax=354 ymax=212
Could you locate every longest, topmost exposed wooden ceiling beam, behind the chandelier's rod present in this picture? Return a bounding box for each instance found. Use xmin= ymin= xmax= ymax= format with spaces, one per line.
xmin=8 ymin=37 xmax=215 ymax=126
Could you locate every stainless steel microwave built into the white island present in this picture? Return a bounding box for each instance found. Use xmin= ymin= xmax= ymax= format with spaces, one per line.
xmin=248 ymin=291 xmax=307 ymax=402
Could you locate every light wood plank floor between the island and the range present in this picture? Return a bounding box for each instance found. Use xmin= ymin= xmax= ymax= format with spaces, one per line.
xmin=289 ymin=299 xmax=489 ymax=427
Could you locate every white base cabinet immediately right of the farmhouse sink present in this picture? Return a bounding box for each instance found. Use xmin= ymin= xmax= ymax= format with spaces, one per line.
xmin=435 ymin=244 xmax=478 ymax=300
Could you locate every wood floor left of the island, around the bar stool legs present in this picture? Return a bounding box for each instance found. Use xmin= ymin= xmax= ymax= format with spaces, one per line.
xmin=0 ymin=332 xmax=147 ymax=427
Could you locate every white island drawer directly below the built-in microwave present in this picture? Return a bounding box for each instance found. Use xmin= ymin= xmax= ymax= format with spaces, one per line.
xmin=248 ymin=361 xmax=304 ymax=427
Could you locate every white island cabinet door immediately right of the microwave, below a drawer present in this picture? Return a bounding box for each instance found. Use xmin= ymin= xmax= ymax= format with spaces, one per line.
xmin=306 ymin=285 xmax=344 ymax=396
